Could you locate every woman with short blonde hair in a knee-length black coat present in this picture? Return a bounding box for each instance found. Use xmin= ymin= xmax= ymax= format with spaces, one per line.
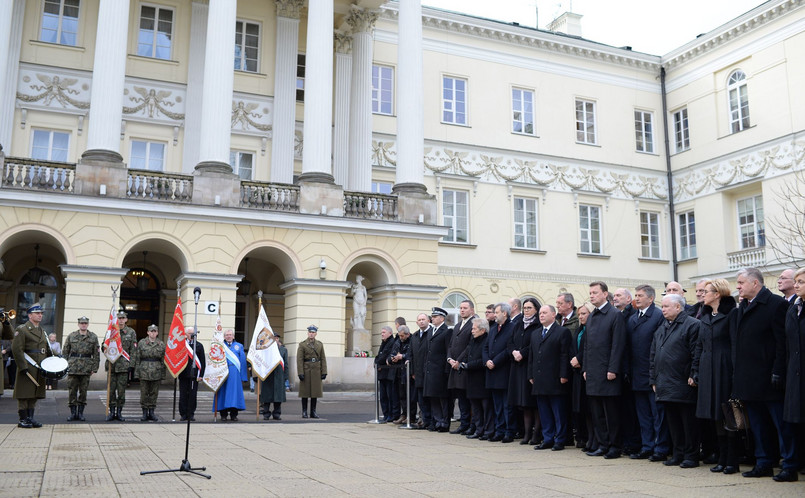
xmin=696 ymin=278 xmax=738 ymax=474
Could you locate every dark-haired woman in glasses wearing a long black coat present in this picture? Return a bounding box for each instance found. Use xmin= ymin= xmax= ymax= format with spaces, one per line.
xmin=508 ymin=297 xmax=542 ymax=444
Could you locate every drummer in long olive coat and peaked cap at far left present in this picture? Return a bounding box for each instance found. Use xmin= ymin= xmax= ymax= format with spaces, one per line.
xmin=11 ymin=303 xmax=52 ymax=429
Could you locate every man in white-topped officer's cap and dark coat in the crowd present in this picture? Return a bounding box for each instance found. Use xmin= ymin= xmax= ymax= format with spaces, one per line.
xmin=424 ymin=307 xmax=452 ymax=432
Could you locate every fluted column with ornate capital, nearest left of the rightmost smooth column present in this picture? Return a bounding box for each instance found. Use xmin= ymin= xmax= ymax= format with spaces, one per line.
xmin=346 ymin=5 xmax=377 ymax=192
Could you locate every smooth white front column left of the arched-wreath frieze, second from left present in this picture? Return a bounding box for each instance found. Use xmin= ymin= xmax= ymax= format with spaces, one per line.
xmin=81 ymin=0 xmax=130 ymax=164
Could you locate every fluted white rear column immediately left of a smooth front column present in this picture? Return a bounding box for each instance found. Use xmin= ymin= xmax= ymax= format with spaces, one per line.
xmin=271 ymin=0 xmax=303 ymax=183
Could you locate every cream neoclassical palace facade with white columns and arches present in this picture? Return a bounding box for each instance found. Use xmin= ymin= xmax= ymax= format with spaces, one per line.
xmin=0 ymin=0 xmax=805 ymax=388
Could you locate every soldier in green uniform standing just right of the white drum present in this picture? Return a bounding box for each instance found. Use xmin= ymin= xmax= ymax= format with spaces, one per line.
xmin=64 ymin=316 xmax=101 ymax=422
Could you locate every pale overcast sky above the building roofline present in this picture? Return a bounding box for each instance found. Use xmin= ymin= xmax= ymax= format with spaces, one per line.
xmin=422 ymin=0 xmax=764 ymax=55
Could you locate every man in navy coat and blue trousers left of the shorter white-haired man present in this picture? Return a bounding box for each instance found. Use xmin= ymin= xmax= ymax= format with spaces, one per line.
xmin=626 ymin=285 xmax=670 ymax=462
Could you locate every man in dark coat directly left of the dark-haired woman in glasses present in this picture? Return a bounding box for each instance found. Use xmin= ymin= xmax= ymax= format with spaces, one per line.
xmin=484 ymin=303 xmax=516 ymax=443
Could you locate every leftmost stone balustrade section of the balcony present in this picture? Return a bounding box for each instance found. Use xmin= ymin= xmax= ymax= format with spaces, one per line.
xmin=2 ymin=157 xmax=75 ymax=193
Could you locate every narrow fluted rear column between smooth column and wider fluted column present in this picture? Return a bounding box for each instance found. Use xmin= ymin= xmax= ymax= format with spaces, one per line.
xmin=333 ymin=32 xmax=352 ymax=187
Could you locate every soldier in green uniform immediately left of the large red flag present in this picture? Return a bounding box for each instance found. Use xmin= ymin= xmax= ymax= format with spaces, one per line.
xmin=133 ymin=325 xmax=165 ymax=422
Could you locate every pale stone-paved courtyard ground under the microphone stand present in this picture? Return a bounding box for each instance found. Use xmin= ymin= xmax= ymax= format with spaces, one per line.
xmin=0 ymin=391 xmax=805 ymax=498
